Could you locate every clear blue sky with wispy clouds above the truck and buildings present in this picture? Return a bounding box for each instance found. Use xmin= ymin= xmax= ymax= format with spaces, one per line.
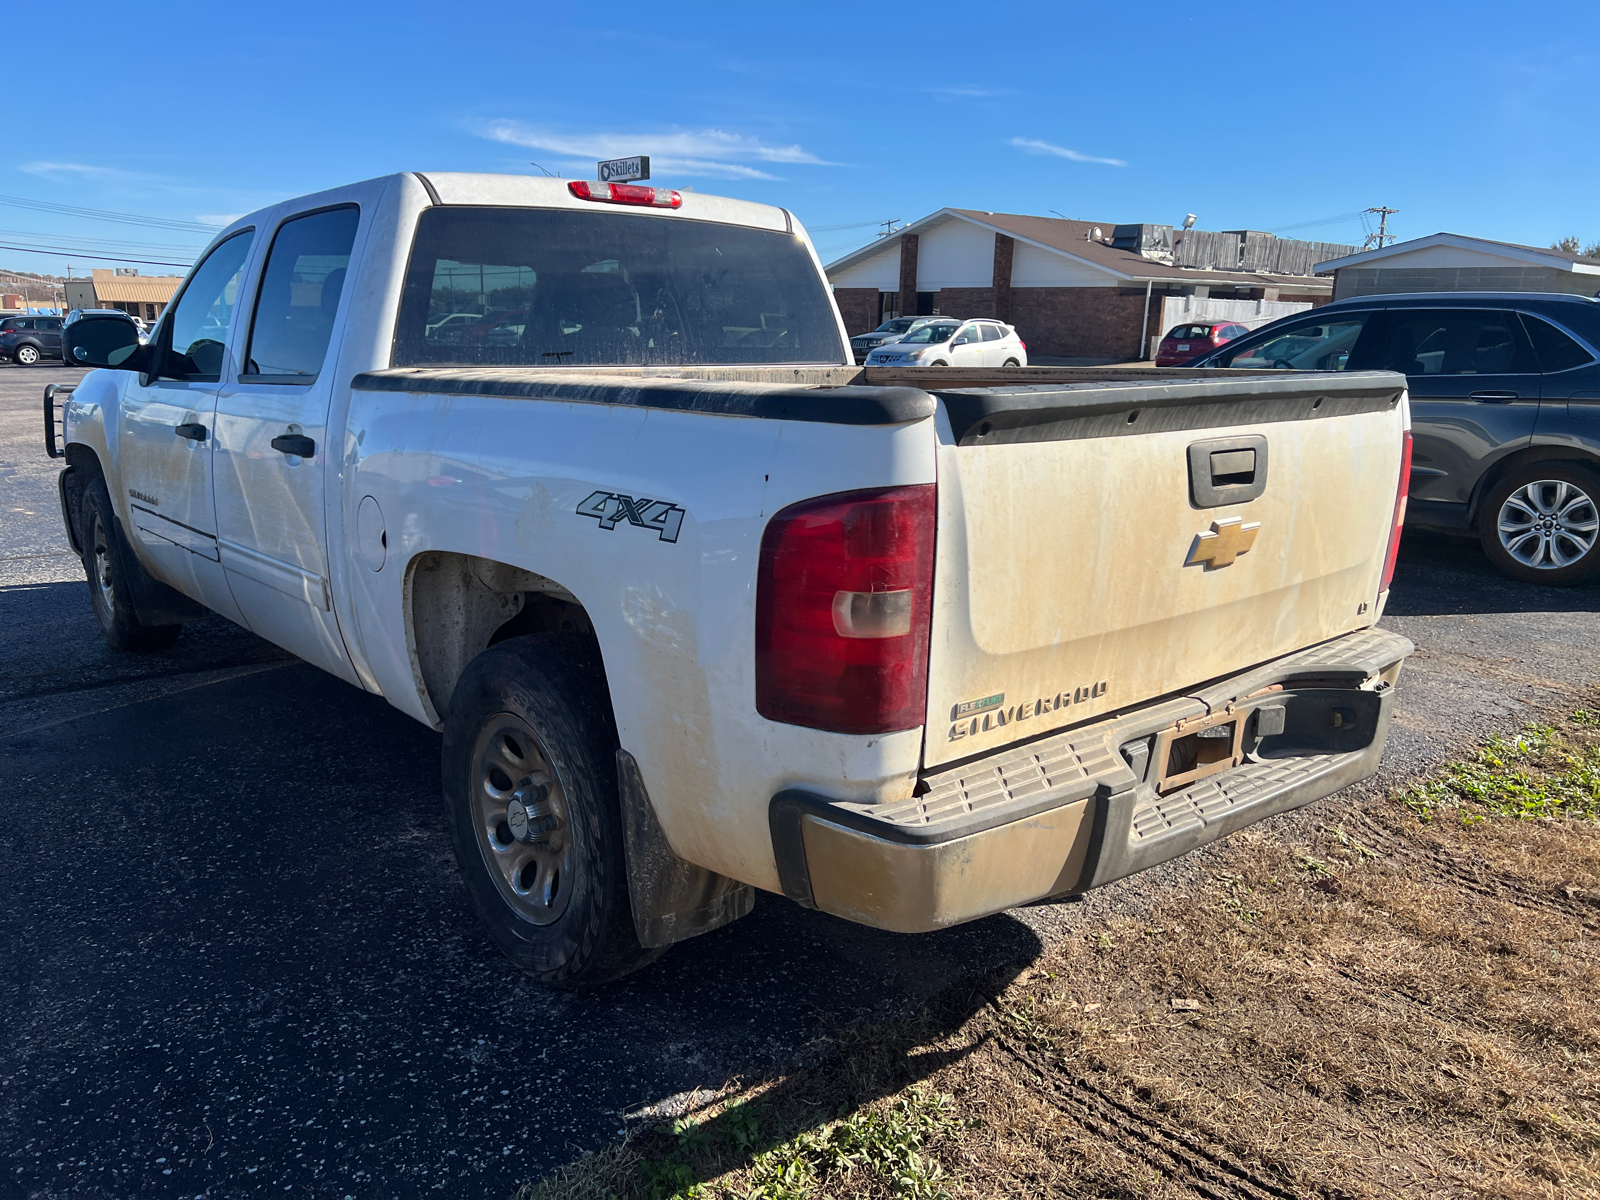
xmin=0 ymin=0 xmax=1600 ymax=274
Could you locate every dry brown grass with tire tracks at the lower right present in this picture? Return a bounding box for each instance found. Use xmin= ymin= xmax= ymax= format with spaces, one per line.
xmin=520 ymin=712 xmax=1600 ymax=1200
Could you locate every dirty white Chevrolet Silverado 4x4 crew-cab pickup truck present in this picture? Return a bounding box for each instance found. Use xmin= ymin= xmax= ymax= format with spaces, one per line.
xmin=46 ymin=174 xmax=1411 ymax=986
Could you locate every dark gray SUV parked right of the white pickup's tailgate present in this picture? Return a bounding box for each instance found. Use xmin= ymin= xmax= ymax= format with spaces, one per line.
xmin=1194 ymin=291 xmax=1600 ymax=584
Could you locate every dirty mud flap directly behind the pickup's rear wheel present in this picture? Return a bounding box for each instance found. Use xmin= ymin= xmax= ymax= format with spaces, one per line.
xmin=616 ymin=750 xmax=755 ymax=949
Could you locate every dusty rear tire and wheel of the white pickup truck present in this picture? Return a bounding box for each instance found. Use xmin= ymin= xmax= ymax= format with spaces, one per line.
xmin=442 ymin=634 xmax=661 ymax=989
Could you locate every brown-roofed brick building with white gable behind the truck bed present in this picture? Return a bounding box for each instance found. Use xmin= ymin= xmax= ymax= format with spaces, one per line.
xmin=827 ymin=208 xmax=1352 ymax=358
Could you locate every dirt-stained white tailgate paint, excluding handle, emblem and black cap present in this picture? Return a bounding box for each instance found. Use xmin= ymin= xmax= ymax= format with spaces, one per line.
xmin=925 ymin=406 xmax=1403 ymax=766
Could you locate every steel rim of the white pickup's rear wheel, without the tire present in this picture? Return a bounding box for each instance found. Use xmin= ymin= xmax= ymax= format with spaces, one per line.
xmin=469 ymin=712 xmax=574 ymax=925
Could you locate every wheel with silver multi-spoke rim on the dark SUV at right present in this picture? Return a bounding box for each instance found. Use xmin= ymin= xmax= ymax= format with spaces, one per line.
xmin=1478 ymin=461 xmax=1600 ymax=587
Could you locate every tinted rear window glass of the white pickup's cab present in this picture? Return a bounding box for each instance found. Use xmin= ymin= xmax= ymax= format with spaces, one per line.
xmin=394 ymin=206 xmax=845 ymax=366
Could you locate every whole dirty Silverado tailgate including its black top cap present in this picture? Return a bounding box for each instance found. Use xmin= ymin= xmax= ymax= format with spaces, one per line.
xmin=925 ymin=373 xmax=1406 ymax=766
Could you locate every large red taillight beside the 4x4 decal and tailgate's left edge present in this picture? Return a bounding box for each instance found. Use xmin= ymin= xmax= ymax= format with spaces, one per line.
xmin=755 ymin=483 xmax=934 ymax=733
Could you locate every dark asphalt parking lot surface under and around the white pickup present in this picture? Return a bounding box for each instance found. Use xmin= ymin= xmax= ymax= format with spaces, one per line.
xmin=0 ymin=366 xmax=1600 ymax=1198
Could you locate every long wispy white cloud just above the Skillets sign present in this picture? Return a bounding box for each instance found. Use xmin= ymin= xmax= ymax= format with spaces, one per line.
xmin=478 ymin=120 xmax=832 ymax=179
